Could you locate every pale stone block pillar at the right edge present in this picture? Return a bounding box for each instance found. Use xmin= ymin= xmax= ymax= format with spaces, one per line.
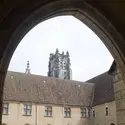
xmin=113 ymin=66 xmax=125 ymax=125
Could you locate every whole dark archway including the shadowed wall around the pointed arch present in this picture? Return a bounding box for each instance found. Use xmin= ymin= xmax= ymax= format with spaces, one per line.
xmin=0 ymin=0 xmax=125 ymax=124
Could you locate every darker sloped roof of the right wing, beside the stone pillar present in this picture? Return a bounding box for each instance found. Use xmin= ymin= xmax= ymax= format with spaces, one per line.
xmin=87 ymin=72 xmax=115 ymax=106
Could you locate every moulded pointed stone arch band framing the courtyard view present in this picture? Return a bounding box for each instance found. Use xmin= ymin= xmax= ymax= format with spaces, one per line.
xmin=0 ymin=0 xmax=125 ymax=123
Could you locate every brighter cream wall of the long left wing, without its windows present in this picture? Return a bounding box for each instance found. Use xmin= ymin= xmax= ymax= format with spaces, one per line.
xmin=2 ymin=101 xmax=88 ymax=125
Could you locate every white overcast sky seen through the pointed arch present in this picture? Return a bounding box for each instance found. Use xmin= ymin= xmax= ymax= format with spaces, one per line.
xmin=9 ymin=16 xmax=113 ymax=81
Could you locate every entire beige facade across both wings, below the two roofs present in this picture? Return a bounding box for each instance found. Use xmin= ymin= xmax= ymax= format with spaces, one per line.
xmin=2 ymin=101 xmax=117 ymax=125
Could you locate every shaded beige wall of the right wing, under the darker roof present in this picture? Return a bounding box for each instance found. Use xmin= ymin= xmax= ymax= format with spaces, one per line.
xmin=90 ymin=101 xmax=117 ymax=125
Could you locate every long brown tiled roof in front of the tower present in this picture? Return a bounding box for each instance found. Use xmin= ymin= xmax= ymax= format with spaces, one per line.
xmin=3 ymin=71 xmax=94 ymax=106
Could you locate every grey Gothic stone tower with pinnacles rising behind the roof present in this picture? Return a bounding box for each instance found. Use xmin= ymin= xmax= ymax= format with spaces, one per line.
xmin=48 ymin=49 xmax=72 ymax=79
